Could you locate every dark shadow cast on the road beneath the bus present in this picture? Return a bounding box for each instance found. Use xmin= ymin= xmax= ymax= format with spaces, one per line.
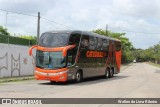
xmin=39 ymin=76 xmax=129 ymax=86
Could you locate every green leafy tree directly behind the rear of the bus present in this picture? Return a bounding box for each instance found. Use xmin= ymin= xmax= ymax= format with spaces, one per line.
xmin=93 ymin=29 xmax=134 ymax=63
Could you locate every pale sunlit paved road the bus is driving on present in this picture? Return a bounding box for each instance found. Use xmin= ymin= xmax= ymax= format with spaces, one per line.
xmin=0 ymin=63 xmax=160 ymax=107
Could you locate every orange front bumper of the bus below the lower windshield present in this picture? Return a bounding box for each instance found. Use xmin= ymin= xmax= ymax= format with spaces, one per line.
xmin=35 ymin=70 xmax=68 ymax=82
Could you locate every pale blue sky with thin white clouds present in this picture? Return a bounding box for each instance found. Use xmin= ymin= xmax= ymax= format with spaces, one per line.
xmin=0 ymin=0 xmax=160 ymax=49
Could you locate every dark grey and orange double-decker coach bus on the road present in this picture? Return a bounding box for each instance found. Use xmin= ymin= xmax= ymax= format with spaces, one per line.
xmin=29 ymin=30 xmax=122 ymax=82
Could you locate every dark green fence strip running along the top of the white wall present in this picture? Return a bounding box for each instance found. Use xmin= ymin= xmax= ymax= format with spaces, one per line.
xmin=0 ymin=35 xmax=36 ymax=46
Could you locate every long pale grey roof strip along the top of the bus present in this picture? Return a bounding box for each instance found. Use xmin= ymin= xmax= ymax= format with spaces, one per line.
xmin=44 ymin=30 xmax=120 ymax=42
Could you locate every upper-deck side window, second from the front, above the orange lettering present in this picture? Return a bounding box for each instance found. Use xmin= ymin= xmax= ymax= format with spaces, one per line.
xmin=89 ymin=36 xmax=97 ymax=50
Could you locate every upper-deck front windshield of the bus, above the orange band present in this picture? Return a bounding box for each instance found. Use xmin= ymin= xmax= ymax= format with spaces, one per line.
xmin=39 ymin=33 xmax=69 ymax=47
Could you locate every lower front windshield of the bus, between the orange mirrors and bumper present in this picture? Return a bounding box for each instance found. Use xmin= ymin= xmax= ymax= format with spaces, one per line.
xmin=36 ymin=50 xmax=66 ymax=69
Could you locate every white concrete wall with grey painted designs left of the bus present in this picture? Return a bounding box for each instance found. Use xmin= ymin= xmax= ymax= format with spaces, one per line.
xmin=0 ymin=43 xmax=34 ymax=78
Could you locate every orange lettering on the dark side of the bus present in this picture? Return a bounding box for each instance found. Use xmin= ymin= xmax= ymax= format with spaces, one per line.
xmin=86 ymin=51 xmax=106 ymax=58
